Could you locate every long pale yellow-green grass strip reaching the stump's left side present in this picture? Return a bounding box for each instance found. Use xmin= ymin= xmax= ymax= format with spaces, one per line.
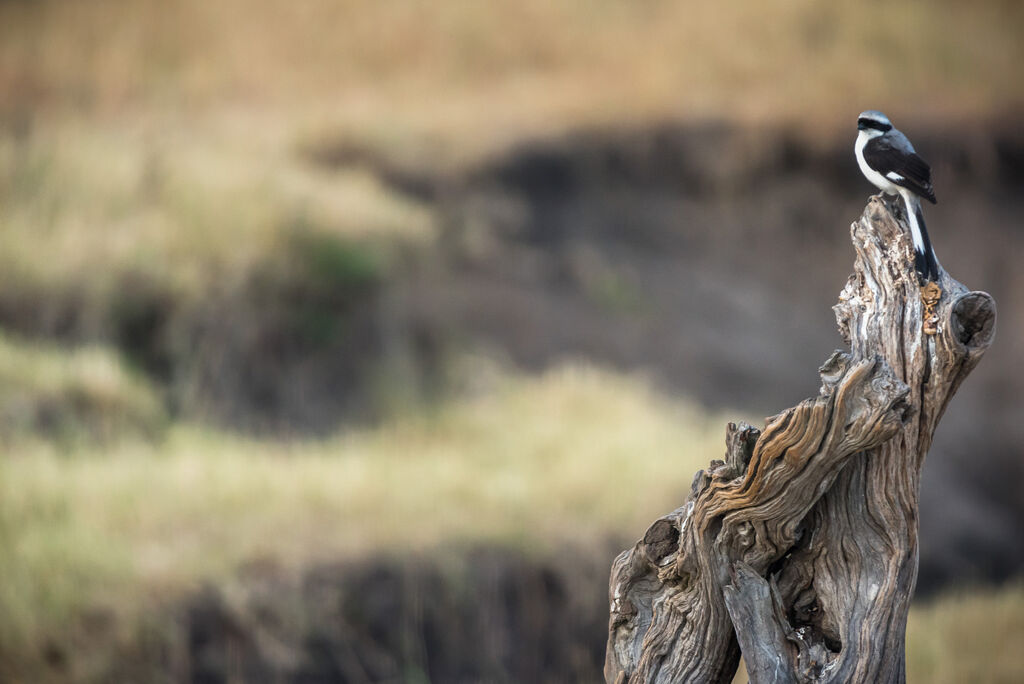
xmin=0 ymin=367 xmax=723 ymax=679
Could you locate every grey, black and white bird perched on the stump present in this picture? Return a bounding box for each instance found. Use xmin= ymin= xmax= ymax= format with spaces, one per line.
xmin=853 ymin=110 xmax=939 ymax=284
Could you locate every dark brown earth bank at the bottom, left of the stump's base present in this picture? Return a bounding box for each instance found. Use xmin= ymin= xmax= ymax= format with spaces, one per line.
xmin=101 ymin=549 xmax=611 ymax=684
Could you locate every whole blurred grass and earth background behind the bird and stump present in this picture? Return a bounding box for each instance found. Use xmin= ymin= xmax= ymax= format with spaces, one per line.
xmin=0 ymin=0 xmax=1024 ymax=682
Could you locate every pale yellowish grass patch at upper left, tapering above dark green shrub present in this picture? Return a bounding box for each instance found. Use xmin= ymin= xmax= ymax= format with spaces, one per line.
xmin=0 ymin=122 xmax=433 ymax=309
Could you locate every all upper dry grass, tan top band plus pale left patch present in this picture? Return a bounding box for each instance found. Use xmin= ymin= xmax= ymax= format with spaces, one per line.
xmin=0 ymin=0 xmax=1024 ymax=342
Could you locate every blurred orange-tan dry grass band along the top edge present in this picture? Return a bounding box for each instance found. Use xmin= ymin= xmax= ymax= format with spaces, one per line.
xmin=0 ymin=0 xmax=1024 ymax=144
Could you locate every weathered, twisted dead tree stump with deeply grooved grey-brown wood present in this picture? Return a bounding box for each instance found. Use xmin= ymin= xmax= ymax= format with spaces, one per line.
xmin=604 ymin=198 xmax=995 ymax=684
